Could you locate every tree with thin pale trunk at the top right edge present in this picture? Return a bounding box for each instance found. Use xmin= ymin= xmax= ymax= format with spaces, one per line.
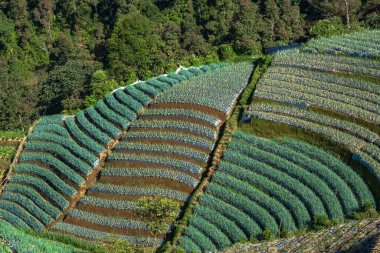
xmin=307 ymin=0 xmax=362 ymax=29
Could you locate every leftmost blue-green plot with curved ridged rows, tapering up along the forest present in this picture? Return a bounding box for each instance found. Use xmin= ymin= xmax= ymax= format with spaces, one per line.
xmin=0 ymin=65 xmax=221 ymax=231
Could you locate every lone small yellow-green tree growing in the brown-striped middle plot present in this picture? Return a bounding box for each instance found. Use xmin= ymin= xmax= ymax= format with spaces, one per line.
xmin=136 ymin=197 xmax=179 ymax=237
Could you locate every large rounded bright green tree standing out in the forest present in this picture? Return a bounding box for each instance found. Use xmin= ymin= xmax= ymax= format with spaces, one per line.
xmin=107 ymin=11 xmax=164 ymax=81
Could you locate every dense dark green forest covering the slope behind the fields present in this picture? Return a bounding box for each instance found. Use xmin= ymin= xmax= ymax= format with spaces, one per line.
xmin=0 ymin=0 xmax=380 ymax=131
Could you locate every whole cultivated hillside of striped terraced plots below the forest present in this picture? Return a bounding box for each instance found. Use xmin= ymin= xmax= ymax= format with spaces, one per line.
xmin=0 ymin=30 xmax=380 ymax=252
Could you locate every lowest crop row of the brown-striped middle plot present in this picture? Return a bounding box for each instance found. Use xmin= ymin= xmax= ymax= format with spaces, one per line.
xmin=53 ymin=222 xmax=162 ymax=246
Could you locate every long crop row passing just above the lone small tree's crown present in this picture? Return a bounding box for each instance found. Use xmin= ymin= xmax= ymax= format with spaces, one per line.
xmin=89 ymin=183 xmax=188 ymax=201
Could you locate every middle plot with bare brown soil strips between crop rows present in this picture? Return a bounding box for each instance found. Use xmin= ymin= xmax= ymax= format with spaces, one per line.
xmin=50 ymin=63 xmax=252 ymax=245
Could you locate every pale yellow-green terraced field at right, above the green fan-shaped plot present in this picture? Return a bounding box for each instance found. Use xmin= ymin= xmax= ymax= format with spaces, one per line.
xmin=246 ymin=50 xmax=380 ymax=189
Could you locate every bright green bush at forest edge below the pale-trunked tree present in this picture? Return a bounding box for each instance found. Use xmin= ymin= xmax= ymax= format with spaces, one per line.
xmin=310 ymin=17 xmax=347 ymax=38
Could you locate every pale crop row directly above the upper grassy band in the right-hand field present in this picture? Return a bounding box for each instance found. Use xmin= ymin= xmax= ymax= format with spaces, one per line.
xmin=255 ymin=85 xmax=380 ymax=124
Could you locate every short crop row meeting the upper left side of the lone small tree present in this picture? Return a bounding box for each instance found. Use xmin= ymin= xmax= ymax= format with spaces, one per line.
xmin=79 ymin=195 xmax=137 ymax=211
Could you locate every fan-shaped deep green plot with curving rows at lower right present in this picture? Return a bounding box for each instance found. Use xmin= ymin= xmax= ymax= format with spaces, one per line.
xmin=180 ymin=131 xmax=375 ymax=252
